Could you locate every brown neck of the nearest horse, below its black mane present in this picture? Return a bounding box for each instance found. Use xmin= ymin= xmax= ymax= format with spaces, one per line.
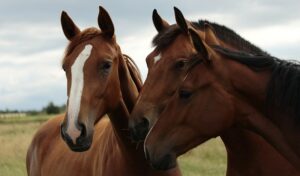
xmin=225 ymin=59 xmax=300 ymax=170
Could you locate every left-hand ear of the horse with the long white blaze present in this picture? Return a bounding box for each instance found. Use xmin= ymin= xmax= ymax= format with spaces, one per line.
xmin=60 ymin=11 xmax=80 ymax=40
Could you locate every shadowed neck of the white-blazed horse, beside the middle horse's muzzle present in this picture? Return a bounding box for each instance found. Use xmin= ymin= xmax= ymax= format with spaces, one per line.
xmin=109 ymin=60 xmax=181 ymax=176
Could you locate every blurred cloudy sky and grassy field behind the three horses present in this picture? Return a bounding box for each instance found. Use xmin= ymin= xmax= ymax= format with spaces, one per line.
xmin=0 ymin=0 xmax=300 ymax=176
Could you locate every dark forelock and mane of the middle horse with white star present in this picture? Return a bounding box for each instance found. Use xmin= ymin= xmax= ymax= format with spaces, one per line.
xmin=152 ymin=20 xmax=269 ymax=55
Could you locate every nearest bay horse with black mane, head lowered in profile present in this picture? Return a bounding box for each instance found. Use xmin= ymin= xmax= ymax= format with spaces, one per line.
xmin=144 ymin=7 xmax=300 ymax=175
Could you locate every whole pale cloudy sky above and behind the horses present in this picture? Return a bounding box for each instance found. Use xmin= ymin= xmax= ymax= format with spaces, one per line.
xmin=0 ymin=0 xmax=300 ymax=110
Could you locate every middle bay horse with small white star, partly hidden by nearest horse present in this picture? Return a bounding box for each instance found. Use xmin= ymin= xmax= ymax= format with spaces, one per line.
xmin=130 ymin=8 xmax=300 ymax=176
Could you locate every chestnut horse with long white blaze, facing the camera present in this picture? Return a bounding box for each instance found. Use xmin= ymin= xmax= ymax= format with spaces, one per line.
xmin=27 ymin=6 xmax=180 ymax=176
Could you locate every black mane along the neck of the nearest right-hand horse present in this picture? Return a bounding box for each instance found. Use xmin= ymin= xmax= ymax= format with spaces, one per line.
xmin=213 ymin=46 xmax=300 ymax=123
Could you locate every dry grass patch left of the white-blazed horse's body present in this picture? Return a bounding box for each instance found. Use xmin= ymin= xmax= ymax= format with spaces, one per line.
xmin=0 ymin=116 xmax=50 ymax=176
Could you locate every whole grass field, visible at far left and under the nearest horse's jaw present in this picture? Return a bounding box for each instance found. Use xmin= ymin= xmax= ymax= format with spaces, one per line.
xmin=0 ymin=116 xmax=226 ymax=176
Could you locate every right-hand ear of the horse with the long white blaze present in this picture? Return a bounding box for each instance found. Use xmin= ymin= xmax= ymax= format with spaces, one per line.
xmin=98 ymin=6 xmax=115 ymax=38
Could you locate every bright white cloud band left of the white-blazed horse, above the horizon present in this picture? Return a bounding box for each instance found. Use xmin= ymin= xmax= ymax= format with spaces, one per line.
xmin=0 ymin=50 xmax=66 ymax=109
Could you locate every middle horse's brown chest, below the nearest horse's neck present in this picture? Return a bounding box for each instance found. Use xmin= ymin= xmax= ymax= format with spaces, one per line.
xmin=221 ymin=127 xmax=297 ymax=176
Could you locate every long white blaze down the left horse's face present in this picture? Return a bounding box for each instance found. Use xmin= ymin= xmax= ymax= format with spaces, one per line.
xmin=67 ymin=44 xmax=93 ymax=144
